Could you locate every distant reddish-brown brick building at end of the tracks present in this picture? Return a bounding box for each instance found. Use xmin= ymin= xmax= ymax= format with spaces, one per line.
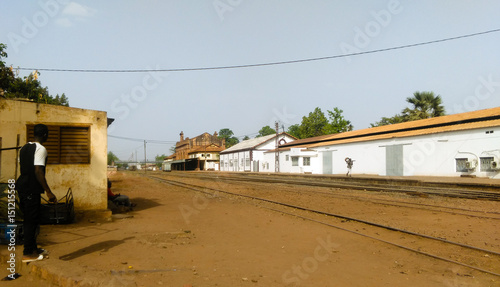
xmin=163 ymin=132 xmax=226 ymax=171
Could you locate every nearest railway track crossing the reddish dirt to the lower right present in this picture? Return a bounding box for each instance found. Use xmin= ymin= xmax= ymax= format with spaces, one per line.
xmin=148 ymin=175 xmax=500 ymax=277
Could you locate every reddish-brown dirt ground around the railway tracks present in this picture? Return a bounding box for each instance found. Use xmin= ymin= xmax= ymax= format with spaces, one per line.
xmin=0 ymin=172 xmax=500 ymax=287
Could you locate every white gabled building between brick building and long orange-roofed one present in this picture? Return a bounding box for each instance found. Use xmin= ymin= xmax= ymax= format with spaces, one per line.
xmin=220 ymin=133 xmax=296 ymax=172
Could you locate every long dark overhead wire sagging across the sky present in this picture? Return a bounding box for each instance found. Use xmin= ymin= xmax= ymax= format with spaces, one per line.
xmin=18 ymin=29 xmax=500 ymax=73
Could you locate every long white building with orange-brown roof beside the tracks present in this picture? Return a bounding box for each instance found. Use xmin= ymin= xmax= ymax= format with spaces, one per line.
xmin=272 ymin=107 xmax=500 ymax=179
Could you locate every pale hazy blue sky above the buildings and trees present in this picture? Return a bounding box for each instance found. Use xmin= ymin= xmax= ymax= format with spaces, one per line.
xmin=0 ymin=0 xmax=500 ymax=159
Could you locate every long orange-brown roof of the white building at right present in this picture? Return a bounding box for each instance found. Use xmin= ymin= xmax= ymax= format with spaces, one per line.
xmin=281 ymin=107 xmax=500 ymax=148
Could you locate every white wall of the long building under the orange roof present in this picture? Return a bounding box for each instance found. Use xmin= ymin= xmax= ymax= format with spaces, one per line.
xmin=274 ymin=127 xmax=500 ymax=179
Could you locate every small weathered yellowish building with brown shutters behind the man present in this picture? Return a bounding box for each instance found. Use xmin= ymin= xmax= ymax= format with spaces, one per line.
xmin=0 ymin=98 xmax=112 ymax=213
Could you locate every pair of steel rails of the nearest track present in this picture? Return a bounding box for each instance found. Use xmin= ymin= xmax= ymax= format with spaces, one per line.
xmin=148 ymin=175 xmax=500 ymax=277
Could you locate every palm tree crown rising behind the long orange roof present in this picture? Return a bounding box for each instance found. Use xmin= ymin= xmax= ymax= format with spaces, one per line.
xmin=403 ymin=91 xmax=445 ymax=121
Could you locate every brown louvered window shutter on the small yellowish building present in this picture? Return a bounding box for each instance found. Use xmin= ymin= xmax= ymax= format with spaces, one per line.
xmin=26 ymin=125 xmax=90 ymax=164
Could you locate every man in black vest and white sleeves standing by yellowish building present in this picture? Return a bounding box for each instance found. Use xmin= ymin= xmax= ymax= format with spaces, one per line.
xmin=16 ymin=124 xmax=57 ymax=262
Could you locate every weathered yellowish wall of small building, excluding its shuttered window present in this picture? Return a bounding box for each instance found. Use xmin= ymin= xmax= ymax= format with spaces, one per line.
xmin=0 ymin=99 xmax=107 ymax=210
